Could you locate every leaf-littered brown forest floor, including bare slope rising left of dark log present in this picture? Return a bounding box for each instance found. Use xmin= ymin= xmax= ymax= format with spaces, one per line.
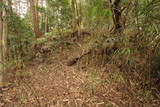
xmin=0 ymin=31 xmax=160 ymax=107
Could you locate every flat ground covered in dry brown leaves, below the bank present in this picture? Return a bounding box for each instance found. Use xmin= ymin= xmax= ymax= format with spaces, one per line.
xmin=0 ymin=60 xmax=157 ymax=107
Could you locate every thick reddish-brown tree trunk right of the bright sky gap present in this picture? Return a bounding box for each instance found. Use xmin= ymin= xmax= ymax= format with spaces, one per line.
xmin=29 ymin=0 xmax=41 ymax=38
